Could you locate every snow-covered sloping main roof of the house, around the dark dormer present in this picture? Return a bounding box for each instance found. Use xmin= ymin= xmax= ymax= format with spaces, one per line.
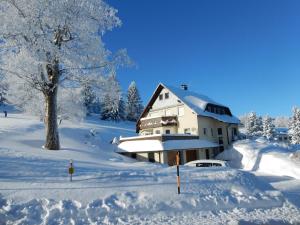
xmin=161 ymin=84 xmax=240 ymax=124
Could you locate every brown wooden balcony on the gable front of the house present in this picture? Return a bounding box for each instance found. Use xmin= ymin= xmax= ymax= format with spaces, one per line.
xmin=139 ymin=116 xmax=178 ymax=130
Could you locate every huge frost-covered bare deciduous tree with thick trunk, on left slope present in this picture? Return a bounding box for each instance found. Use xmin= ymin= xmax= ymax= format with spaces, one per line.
xmin=0 ymin=0 xmax=127 ymax=149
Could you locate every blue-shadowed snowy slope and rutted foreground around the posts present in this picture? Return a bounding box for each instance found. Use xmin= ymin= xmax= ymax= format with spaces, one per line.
xmin=0 ymin=114 xmax=300 ymax=224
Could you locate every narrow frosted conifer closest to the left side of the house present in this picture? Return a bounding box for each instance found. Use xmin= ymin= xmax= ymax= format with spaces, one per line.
xmin=126 ymin=81 xmax=143 ymax=121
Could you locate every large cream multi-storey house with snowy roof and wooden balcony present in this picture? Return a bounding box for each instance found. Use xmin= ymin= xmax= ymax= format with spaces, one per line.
xmin=117 ymin=84 xmax=240 ymax=165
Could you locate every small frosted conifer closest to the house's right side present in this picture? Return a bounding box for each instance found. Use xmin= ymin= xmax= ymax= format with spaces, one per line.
xmin=245 ymin=112 xmax=262 ymax=137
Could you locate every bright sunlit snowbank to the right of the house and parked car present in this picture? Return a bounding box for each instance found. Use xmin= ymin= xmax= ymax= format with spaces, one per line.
xmin=218 ymin=138 xmax=300 ymax=179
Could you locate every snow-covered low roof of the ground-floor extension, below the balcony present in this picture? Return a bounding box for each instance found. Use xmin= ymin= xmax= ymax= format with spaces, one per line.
xmin=117 ymin=139 xmax=219 ymax=152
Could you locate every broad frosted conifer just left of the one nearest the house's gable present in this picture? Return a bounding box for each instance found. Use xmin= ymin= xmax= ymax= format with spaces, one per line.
xmin=100 ymin=73 xmax=126 ymax=121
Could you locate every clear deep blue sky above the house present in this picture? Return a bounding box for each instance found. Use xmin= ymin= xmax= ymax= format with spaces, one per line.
xmin=104 ymin=0 xmax=300 ymax=116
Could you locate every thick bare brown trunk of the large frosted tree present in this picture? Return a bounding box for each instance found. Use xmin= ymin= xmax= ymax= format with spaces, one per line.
xmin=45 ymin=87 xmax=60 ymax=150
